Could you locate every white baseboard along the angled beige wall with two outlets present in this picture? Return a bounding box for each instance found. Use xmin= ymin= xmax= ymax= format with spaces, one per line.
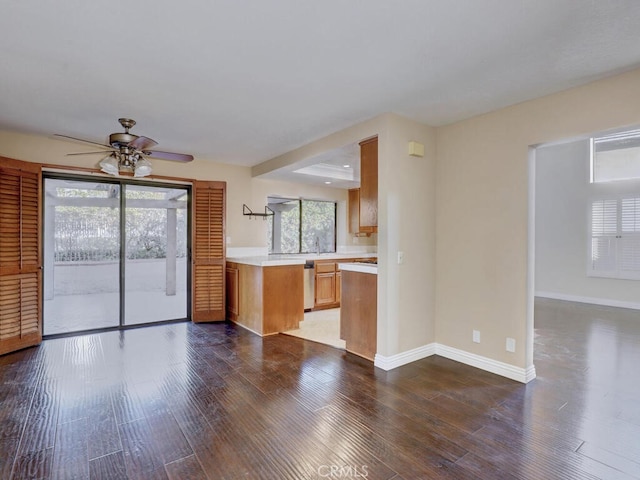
xmin=374 ymin=343 xmax=536 ymax=383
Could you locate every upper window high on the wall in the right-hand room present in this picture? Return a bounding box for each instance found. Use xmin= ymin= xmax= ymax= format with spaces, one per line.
xmin=591 ymin=130 xmax=640 ymax=183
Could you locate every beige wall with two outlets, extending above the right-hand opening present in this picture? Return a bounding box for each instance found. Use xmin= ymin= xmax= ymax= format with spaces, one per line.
xmin=436 ymin=66 xmax=640 ymax=368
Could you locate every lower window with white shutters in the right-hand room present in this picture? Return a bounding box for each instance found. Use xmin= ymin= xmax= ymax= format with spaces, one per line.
xmin=588 ymin=197 xmax=640 ymax=280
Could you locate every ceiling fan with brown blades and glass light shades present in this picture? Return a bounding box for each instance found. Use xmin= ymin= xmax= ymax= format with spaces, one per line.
xmin=55 ymin=118 xmax=193 ymax=177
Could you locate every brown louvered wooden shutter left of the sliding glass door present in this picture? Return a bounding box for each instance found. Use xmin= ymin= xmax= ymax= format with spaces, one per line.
xmin=0 ymin=157 xmax=42 ymax=355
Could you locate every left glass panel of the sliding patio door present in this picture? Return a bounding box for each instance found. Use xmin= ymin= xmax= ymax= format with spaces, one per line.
xmin=43 ymin=178 xmax=120 ymax=335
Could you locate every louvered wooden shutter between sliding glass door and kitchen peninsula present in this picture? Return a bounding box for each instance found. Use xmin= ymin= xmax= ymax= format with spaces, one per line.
xmin=191 ymin=182 xmax=226 ymax=322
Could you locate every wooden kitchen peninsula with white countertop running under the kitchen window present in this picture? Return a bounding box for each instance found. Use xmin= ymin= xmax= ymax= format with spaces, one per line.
xmin=226 ymin=253 xmax=375 ymax=335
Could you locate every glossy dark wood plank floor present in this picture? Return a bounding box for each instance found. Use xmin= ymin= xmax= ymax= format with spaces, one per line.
xmin=0 ymin=300 xmax=640 ymax=480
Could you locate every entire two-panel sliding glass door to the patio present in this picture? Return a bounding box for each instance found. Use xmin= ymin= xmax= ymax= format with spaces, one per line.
xmin=43 ymin=176 xmax=189 ymax=335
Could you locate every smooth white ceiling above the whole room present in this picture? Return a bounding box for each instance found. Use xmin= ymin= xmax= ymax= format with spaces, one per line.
xmin=0 ymin=0 xmax=640 ymax=178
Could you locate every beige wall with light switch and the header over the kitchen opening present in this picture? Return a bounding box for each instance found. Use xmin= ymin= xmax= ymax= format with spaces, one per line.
xmin=253 ymin=114 xmax=436 ymax=357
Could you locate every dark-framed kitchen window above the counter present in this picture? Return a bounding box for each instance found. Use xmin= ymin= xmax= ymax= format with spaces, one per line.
xmin=267 ymin=197 xmax=336 ymax=253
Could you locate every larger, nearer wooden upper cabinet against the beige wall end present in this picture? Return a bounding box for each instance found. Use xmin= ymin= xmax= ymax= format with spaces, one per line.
xmin=360 ymin=137 xmax=378 ymax=232
